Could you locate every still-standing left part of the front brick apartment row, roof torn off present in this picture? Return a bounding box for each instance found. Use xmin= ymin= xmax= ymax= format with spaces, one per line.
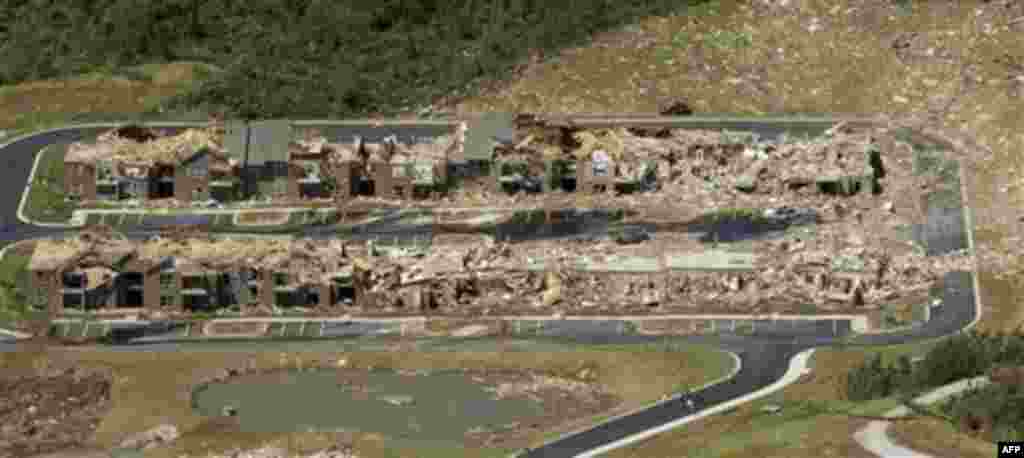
xmin=28 ymin=231 xmax=353 ymax=314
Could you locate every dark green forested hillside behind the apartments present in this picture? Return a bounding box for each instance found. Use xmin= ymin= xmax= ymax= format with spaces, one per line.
xmin=0 ymin=0 xmax=716 ymax=117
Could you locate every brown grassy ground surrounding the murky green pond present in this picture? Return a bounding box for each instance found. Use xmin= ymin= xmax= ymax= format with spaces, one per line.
xmin=0 ymin=342 xmax=718 ymax=458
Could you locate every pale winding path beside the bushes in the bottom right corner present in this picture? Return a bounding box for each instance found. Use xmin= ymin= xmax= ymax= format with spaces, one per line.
xmin=853 ymin=376 xmax=991 ymax=458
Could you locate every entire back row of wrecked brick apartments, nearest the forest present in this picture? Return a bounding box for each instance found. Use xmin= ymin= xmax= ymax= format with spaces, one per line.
xmin=65 ymin=116 xmax=883 ymax=203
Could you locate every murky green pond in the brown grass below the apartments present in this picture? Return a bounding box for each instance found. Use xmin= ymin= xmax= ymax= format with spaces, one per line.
xmin=193 ymin=369 xmax=544 ymax=441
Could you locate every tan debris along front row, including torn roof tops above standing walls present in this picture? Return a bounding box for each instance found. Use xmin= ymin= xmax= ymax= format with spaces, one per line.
xmin=30 ymin=215 xmax=973 ymax=316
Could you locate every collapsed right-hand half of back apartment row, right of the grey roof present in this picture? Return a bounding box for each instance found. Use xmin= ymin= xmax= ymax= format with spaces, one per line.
xmin=494 ymin=115 xmax=884 ymax=196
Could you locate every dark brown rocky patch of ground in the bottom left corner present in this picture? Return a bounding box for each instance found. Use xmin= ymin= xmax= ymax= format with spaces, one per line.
xmin=0 ymin=369 xmax=111 ymax=457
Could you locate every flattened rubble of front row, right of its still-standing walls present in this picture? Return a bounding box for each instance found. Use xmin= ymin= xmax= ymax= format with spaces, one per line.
xmin=350 ymin=227 xmax=971 ymax=313
